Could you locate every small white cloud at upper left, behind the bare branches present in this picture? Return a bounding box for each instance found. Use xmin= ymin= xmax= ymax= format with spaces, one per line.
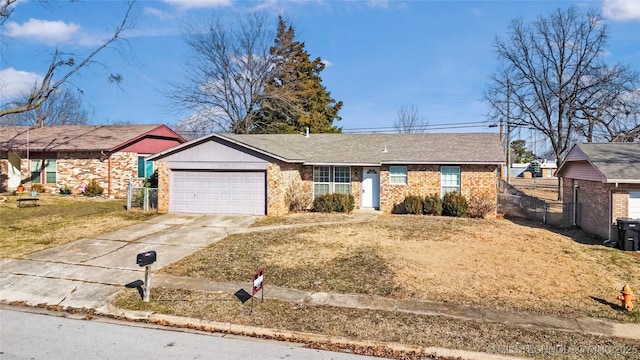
xmin=5 ymin=19 xmax=80 ymax=44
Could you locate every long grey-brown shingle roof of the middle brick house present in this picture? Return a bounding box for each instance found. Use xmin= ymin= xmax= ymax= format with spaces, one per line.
xmin=213 ymin=133 xmax=505 ymax=164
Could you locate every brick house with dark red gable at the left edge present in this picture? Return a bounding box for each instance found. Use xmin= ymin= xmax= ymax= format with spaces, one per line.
xmin=0 ymin=125 xmax=185 ymax=197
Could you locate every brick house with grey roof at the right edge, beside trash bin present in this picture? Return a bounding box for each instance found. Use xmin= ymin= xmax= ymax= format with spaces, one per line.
xmin=556 ymin=143 xmax=640 ymax=240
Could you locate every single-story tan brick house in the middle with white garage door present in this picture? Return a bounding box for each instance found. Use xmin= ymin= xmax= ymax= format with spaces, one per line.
xmin=147 ymin=133 xmax=504 ymax=215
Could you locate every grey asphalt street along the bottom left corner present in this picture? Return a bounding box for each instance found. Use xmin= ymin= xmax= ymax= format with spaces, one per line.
xmin=0 ymin=307 xmax=377 ymax=360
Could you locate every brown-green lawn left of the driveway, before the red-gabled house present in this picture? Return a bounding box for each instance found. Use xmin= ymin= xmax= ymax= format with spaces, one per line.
xmin=0 ymin=194 xmax=156 ymax=258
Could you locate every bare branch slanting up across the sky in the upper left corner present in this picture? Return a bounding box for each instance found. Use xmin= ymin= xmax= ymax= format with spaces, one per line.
xmin=0 ymin=0 xmax=135 ymax=118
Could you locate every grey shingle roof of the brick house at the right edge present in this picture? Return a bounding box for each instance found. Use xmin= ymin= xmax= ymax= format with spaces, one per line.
xmin=578 ymin=143 xmax=640 ymax=181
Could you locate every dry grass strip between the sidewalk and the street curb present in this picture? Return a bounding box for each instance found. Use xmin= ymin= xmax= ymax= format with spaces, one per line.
xmin=114 ymin=288 xmax=640 ymax=360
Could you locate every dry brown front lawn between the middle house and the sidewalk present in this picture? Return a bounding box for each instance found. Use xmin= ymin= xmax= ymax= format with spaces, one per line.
xmin=162 ymin=215 xmax=640 ymax=321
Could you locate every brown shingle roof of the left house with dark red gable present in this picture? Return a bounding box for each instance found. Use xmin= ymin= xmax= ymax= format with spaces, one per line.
xmin=0 ymin=125 xmax=162 ymax=151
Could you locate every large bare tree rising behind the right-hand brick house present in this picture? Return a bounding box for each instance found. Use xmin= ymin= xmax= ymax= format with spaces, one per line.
xmin=485 ymin=6 xmax=639 ymax=197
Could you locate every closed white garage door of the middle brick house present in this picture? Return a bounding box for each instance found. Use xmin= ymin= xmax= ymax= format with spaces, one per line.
xmin=169 ymin=171 xmax=266 ymax=215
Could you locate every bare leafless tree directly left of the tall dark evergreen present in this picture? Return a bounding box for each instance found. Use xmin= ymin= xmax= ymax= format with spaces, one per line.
xmin=167 ymin=12 xmax=275 ymax=133
